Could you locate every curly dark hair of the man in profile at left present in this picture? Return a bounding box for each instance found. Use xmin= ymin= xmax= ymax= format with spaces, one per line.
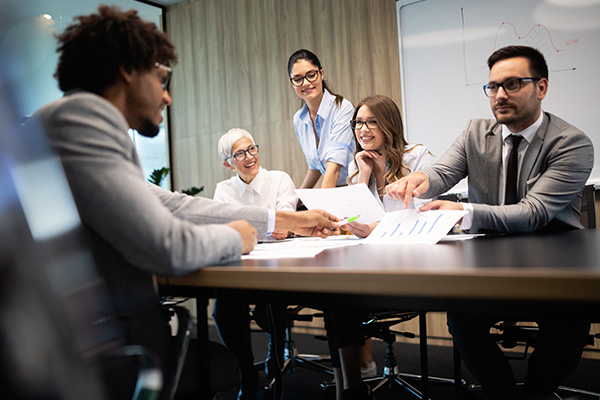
xmin=54 ymin=4 xmax=177 ymax=94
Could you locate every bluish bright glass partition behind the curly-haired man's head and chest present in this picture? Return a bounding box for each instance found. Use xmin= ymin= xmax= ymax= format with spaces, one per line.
xmin=0 ymin=0 xmax=169 ymax=188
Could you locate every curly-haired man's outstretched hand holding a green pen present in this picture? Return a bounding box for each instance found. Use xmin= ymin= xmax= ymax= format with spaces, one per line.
xmin=275 ymin=210 xmax=340 ymax=238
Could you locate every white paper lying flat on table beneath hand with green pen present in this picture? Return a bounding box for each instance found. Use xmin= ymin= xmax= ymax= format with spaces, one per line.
xmin=242 ymin=235 xmax=362 ymax=260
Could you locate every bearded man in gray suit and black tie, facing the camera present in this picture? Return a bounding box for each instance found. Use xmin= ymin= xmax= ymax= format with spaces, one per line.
xmin=386 ymin=46 xmax=594 ymax=399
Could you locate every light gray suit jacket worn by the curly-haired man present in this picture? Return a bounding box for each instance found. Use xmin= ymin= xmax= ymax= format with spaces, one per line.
xmin=36 ymin=92 xmax=268 ymax=314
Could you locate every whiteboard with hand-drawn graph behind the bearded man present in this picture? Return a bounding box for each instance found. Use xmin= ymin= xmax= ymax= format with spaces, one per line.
xmin=396 ymin=0 xmax=600 ymax=191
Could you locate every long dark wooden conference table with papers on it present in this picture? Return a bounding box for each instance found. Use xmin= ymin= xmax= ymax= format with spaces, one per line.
xmin=160 ymin=229 xmax=600 ymax=400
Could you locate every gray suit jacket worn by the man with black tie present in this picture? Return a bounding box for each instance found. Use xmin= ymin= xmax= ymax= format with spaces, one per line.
xmin=421 ymin=113 xmax=594 ymax=232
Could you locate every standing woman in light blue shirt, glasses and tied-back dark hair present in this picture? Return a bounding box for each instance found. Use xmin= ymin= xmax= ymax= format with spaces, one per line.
xmin=288 ymin=49 xmax=355 ymax=189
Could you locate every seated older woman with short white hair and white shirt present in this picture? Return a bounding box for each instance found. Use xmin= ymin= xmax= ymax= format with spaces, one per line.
xmin=213 ymin=128 xmax=298 ymax=400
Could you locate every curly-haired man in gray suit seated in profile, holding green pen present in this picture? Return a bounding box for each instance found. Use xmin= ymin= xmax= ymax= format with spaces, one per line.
xmin=31 ymin=6 xmax=339 ymax=400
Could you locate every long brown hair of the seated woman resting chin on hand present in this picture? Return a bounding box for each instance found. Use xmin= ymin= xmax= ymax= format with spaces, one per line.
xmin=348 ymin=95 xmax=416 ymax=189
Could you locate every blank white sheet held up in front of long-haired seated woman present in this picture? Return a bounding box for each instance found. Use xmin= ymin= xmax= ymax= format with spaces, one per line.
xmin=296 ymin=183 xmax=385 ymax=224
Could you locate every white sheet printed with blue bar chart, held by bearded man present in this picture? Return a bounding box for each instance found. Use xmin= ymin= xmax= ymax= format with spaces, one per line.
xmin=363 ymin=210 xmax=467 ymax=244
